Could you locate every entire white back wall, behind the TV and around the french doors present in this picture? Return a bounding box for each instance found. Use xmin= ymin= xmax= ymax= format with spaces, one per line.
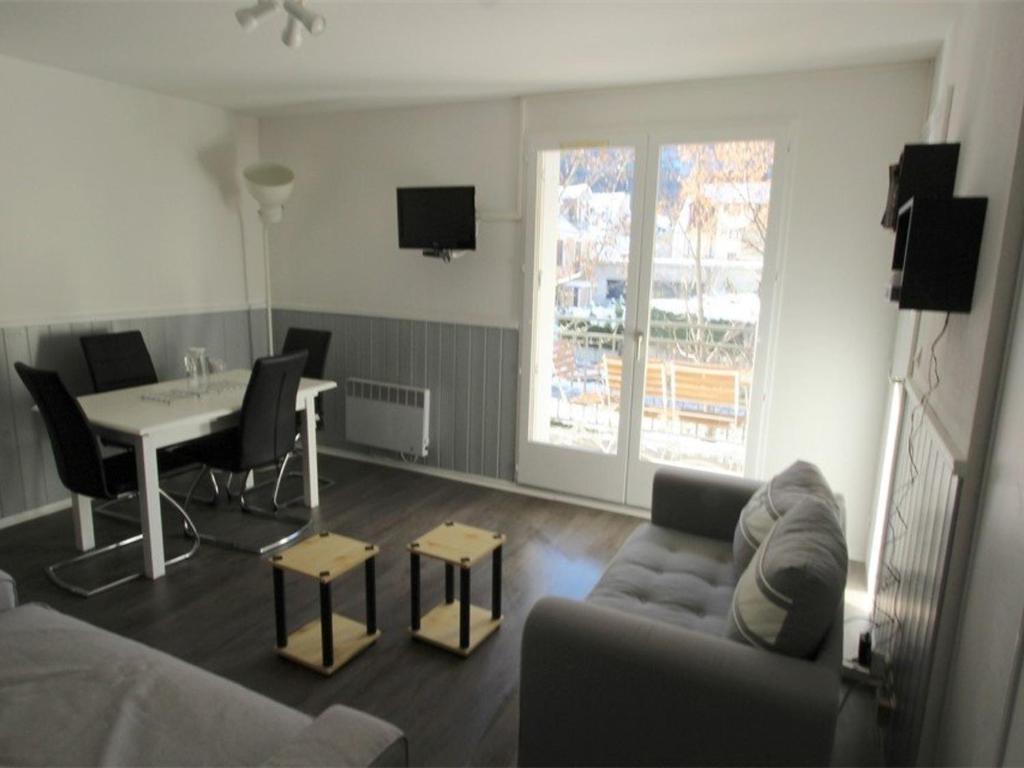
xmin=260 ymin=62 xmax=932 ymax=559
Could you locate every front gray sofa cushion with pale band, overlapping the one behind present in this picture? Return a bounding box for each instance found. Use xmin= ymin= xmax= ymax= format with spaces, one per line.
xmin=727 ymin=498 xmax=847 ymax=657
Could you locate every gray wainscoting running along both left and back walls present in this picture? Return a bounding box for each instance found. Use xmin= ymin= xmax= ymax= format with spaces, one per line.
xmin=0 ymin=310 xmax=519 ymax=517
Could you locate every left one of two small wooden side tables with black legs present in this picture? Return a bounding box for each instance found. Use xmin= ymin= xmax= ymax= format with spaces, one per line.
xmin=270 ymin=531 xmax=381 ymax=675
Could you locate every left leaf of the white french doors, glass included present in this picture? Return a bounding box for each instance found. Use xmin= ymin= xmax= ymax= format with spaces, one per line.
xmin=517 ymin=134 xmax=647 ymax=502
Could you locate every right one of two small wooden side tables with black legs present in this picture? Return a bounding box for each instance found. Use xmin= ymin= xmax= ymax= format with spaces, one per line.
xmin=409 ymin=521 xmax=505 ymax=656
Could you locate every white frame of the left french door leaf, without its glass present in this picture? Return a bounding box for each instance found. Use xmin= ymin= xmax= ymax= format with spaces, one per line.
xmin=516 ymin=129 xmax=647 ymax=504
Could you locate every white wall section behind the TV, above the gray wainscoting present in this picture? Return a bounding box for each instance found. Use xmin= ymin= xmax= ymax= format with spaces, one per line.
xmin=260 ymin=99 xmax=522 ymax=328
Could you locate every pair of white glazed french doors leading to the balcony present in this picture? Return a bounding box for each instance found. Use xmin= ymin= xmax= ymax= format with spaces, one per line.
xmin=518 ymin=129 xmax=784 ymax=508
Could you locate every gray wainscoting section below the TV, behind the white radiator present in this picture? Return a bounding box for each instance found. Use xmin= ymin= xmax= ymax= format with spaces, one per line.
xmin=274 ymin=309 xmax=519 ymax=480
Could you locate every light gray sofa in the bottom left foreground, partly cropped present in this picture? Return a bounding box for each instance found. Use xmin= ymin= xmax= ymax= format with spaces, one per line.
xmin=0 ymin=571 xmax=408 ymax=766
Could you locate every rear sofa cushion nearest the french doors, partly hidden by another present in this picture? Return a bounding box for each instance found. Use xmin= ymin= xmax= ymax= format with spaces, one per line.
xmin=732 ymin=461 xmax=838 ymax=578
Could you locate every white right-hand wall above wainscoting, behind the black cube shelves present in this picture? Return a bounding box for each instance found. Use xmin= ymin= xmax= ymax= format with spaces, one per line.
xmin=914 ymin=3 xmax=1024 ymax=455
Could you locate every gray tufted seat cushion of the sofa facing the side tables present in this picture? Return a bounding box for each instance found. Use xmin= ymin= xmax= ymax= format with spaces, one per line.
xmin=587 ymin=524 xmax=736 ymax=635
